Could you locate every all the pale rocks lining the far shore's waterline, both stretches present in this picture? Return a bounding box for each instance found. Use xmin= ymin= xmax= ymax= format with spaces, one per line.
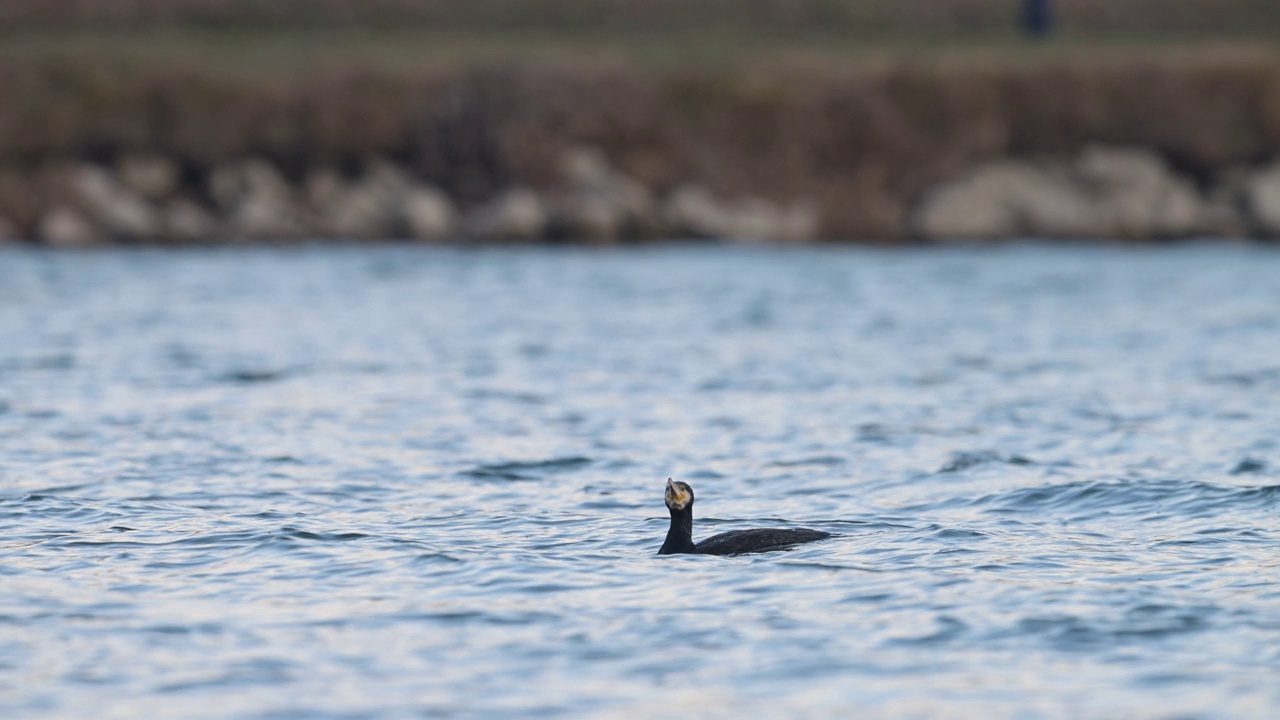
xmin=0 ymin=146 xmax=1280 ymax=247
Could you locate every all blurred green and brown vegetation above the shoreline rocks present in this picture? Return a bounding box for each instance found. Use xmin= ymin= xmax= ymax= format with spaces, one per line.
xmin=0 ymin=0 xmax=1280 ymax=237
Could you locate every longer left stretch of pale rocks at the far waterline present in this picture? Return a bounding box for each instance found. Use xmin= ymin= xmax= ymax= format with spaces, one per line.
xmin=0 ymin=149 xmax=819 ymax=247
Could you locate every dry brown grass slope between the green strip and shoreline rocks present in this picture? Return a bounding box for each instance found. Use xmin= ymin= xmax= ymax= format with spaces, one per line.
xmin=0 ymin=39 xmax=1280 ymax=238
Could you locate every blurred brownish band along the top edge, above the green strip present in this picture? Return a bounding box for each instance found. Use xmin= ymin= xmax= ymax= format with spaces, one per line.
xmin=0 ymin=0 xmax=1280 ymax=40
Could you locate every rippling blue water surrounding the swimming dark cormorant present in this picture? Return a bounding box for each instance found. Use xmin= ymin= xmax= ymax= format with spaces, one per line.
xmin=0 ymin=246 xmax=1280 ymax=719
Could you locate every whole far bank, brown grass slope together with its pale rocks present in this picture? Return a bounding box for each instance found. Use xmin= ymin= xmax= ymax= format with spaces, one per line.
xmin=0 ymin=50 xmax=1280 ymax=246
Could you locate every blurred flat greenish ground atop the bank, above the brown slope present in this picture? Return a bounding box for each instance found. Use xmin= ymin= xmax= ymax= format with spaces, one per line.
xmin=0 ymin=0 xmax=1280 ymax=73
